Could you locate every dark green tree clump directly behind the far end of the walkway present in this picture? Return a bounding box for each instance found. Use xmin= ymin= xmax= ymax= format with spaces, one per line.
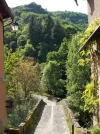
xmin=41 ymin=38 xmax=68 ymax=98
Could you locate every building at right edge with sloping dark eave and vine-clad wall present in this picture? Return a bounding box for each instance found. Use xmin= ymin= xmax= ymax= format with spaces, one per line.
xmin=80 ymin=0 xmax=100 ymax=125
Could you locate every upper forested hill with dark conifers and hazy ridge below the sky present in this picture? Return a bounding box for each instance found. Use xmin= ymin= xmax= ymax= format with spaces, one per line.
xmin=5 ymin=2 xmax=88 ymax=62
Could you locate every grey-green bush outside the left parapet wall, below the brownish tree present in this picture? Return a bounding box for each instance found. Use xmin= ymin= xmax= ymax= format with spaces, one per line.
xmin=8 ymin=99 xmax=36 ymax=128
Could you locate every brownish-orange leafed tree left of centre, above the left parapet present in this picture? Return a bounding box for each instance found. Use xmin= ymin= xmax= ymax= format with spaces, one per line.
xmin=12 ymin=59 xmax=40 ymax=100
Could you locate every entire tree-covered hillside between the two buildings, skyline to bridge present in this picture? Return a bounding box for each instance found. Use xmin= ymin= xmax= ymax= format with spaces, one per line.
xmin=4 ymin=3 xmax=91 ymax=129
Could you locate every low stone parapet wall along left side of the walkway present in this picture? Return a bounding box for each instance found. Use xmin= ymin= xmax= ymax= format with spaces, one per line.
xmin=8 ymin=100 xmax=45 ymax=134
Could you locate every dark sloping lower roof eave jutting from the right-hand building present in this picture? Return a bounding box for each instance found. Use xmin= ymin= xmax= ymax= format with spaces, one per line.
xmin=79 ymin=26 xmax=100 ymax=52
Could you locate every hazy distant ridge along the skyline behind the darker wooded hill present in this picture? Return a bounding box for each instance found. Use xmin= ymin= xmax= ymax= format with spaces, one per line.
xmin=12 ymin=2 xmax=88 ymax=28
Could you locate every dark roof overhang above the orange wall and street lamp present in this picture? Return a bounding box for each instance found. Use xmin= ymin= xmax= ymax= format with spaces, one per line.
xmin=0 ymin=0 xmax=14 ymax=20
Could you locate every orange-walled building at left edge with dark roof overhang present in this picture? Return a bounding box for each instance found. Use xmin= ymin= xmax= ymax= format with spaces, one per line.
xmin=0 ymin=0 xmax=13 ymax=134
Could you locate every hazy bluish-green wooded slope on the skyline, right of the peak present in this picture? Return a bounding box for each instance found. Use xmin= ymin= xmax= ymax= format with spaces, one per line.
xmin=52 ymin=11 xmax=88 ymax=31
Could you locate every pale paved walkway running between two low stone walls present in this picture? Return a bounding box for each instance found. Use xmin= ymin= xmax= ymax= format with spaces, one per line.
xmin=34 ymin=98 xmax=70 ymax=134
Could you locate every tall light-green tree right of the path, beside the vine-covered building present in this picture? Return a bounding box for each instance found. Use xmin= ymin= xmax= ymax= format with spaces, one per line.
xmin=66 ymin=34 xmax=91 ymax=127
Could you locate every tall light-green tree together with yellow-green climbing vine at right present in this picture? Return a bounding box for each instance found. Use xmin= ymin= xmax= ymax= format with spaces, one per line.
xmin=66 ymin=19 xmax=100 ymax=127
